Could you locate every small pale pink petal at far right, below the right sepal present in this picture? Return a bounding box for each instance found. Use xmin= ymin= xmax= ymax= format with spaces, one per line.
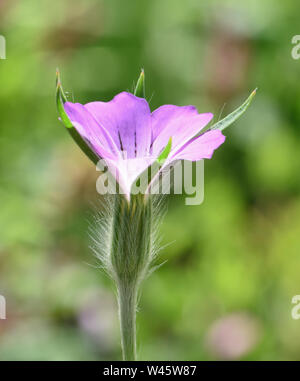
xmin=169 ymin=130 xmax=225 ymax=161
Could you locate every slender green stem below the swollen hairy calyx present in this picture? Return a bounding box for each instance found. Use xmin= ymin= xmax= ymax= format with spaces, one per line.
xmin=118 ymin=284 xmax=137 ymax=361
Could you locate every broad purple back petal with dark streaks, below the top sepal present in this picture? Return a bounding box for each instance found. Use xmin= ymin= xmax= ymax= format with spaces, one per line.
xmin=84 ymin=92 xmax=151 ymax=158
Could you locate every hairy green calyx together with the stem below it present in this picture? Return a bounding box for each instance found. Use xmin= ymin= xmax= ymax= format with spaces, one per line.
xmin=94 ymin=194 xmax=162 ymax=361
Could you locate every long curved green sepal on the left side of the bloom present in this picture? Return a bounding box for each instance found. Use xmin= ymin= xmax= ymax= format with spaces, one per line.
xmin=56 ymin=69 xmax=99 ymax=164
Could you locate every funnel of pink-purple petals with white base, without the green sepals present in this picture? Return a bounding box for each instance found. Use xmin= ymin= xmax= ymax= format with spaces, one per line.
xmin=64 ymin=92 xmax=225 ymax=197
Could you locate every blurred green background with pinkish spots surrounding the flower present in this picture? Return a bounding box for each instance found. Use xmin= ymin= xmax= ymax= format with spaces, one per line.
xmin=0 ymin=0 xmax=300 ymax=360
